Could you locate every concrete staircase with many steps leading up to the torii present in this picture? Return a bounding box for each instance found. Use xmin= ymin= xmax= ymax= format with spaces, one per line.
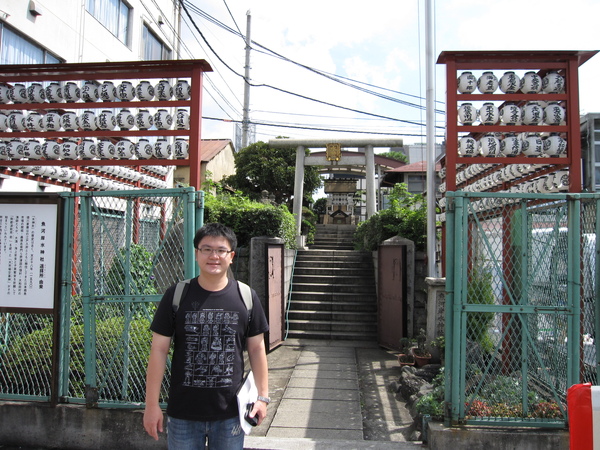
xmin=288 ymin=225 xmax=377 ymax=341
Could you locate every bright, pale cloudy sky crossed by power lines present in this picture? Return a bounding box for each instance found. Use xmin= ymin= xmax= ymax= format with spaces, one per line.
xmin=181 ymin=0 xmax=600 ymax=153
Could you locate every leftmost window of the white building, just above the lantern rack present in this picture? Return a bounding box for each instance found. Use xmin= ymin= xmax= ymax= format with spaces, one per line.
xmin=0 ymin=24 xmax=62 ymax=64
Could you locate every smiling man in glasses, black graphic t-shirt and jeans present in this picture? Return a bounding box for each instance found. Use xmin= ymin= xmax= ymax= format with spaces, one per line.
xmin=144 ymin=223 xmax=269 ymax=450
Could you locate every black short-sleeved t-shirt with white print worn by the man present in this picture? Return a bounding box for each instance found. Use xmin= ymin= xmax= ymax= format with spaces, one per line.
xmin=150 ymin=278 xmax=269 ymax=421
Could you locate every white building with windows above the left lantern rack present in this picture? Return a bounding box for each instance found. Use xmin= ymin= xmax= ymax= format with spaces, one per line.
xmin=0 ymin=0 xmax=180 ymax=64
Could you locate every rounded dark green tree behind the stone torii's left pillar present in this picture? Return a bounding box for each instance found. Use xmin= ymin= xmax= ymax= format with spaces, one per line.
xmin=223 ymin=141 xmax=322 ymax=205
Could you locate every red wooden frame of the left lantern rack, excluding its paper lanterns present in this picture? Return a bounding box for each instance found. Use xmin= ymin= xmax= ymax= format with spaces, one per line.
xmin=0 ymin=60 xmax=212 ymax=191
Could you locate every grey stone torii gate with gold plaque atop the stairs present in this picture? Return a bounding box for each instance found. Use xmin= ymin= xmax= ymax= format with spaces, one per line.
xmin=269 ymin=138 xmax=403 ymax=247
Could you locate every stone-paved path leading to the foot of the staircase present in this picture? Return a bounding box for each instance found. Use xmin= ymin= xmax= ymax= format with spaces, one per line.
xmin=245 ymin=339 xmax=422 ymax=450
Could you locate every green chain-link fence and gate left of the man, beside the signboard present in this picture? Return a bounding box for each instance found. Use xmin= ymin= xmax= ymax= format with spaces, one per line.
xmin=0 ymin=188 xmax=203 ymax=407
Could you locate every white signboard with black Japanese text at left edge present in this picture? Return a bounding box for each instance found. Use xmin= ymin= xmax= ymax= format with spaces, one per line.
xmin=0 ymin=203 xmax=58 ymax=309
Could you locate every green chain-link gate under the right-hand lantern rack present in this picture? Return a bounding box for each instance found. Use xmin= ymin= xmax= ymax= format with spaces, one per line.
xmin=445 ymin=192 xmax=600 ymax=427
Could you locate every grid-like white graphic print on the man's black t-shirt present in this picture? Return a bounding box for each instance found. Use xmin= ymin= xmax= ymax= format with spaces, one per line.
xmin=183 ymin=309 xmax=239 ymax=388
